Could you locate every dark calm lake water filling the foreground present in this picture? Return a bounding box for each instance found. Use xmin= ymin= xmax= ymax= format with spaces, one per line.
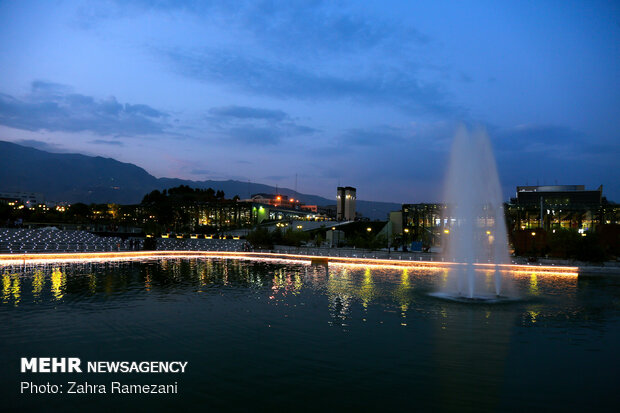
xmin=0 ymin=259 xmax=620 ymax=412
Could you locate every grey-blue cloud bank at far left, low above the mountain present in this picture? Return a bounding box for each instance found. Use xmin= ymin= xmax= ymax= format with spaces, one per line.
xmin=0 ymin=81 xmax=168 ymax=136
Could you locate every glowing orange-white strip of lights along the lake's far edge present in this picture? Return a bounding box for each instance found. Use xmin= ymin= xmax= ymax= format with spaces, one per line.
xmin=0 ymin=251 xmax=580 ymax=277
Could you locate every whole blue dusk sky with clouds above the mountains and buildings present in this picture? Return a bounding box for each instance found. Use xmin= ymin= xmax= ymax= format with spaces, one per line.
xmin=0 ymin=0 xmax=620 ymax=202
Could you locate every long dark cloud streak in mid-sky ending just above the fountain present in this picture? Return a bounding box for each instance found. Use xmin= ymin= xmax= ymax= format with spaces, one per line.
xmin=165 ymin=50 xmax=459 ymax=114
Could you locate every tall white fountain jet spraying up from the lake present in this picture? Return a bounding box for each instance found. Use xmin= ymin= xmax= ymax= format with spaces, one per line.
xmin=443 ymin=127 xmax=510 ymax=299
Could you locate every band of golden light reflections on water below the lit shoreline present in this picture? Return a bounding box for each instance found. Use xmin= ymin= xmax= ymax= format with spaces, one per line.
xmin=2 ymin=258 xmax=596 ymax=327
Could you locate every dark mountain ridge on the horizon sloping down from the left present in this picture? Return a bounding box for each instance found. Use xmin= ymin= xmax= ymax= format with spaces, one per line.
xmin=0 ymin=141 xmax=400 ymax=219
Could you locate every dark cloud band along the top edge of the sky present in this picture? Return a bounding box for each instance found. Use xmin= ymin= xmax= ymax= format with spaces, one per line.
xmin=88 ymin=0 xmax=430 ymax=57
